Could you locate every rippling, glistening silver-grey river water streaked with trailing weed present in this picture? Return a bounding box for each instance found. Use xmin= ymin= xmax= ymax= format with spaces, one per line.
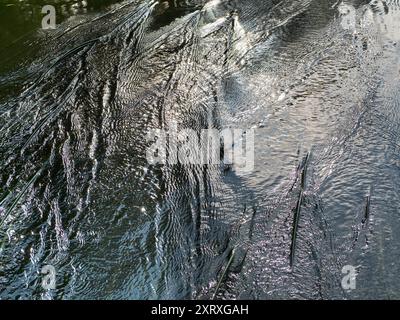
xmin=0 ymin=0 xmax=400 ymax=299
